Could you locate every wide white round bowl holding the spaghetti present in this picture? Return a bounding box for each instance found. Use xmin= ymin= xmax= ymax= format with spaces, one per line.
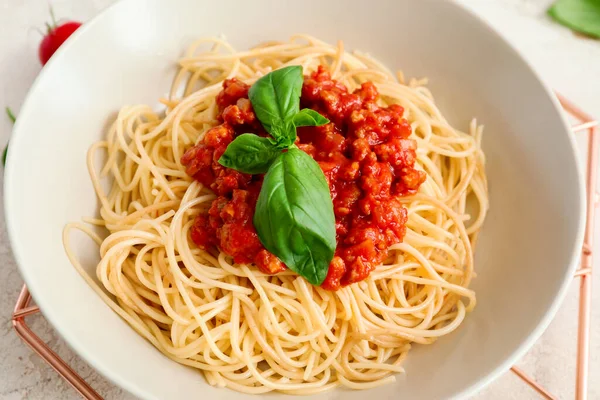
xmin=4 ymin=0 xmax=584 ymax=400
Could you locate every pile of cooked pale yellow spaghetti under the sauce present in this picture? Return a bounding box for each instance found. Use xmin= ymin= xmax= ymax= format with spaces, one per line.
xmin=63 ymin=35 xmax=488 ymax=395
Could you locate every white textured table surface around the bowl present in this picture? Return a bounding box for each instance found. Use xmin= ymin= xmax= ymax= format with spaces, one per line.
xmin=0 ymin=0 xmax=600 ymax=400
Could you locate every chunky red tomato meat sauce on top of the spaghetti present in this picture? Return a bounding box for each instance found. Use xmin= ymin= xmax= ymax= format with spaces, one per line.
xmin=181 ymin=66 xmax=426 ymax=290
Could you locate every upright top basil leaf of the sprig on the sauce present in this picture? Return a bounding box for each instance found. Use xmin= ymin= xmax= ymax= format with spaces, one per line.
xmin=248 ymin=65 xmax=304 ymax=145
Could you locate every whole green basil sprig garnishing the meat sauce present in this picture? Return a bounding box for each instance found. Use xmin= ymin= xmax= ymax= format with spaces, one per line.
xmin=219 ymin=66 xmax=336 ymax=285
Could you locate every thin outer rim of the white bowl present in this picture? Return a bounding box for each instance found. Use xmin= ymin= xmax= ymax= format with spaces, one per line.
xmin=4 ymin=0 xmax=587 ymax=399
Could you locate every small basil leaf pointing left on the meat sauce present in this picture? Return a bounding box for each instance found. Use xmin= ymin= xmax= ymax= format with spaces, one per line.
xmin=219 ymin=133 xmax=281 ymax=174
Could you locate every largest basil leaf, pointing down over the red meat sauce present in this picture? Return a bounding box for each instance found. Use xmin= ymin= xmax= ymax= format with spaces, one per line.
xmin=254 ymin=148 xmax=336 ymax=285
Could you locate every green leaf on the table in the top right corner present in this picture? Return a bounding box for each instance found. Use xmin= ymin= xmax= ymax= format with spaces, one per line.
xmin=548 ymin=0 xmax=600 ymax=38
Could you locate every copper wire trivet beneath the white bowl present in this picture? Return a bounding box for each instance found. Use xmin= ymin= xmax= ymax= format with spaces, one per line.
xmin=12 ymin=94 xmax=600 ymax=400
